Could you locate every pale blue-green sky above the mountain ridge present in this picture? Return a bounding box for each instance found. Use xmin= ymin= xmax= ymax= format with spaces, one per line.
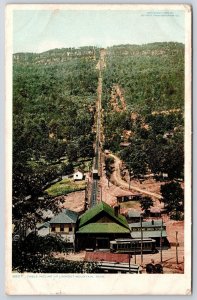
xmin=13 ymin=9 xmax=185 ymax=53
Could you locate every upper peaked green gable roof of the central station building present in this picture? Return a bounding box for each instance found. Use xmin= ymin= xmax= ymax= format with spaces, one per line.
xmin=79 ymin=201 xmax=128 ymax=228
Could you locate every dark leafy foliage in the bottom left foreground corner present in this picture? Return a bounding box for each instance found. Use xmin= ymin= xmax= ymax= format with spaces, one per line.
xmin=12 ymin=233 xmax=99 ymax=273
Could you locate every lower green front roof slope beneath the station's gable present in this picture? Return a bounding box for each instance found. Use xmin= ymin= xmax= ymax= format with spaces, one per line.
xmin=77 ymin=223 xmax=130 ymax=234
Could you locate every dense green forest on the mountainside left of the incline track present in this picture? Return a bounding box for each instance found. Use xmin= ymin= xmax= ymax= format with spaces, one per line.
xmin=13 ymin=47 xmax=98 ymax=219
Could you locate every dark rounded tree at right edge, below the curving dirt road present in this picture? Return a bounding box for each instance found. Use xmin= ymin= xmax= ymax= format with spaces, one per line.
xmin=160 ymin=181 xmax=184 ymax=220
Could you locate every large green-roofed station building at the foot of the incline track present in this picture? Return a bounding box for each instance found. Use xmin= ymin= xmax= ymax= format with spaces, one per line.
xmin=76 ymin=201 xmax=131 ymax=250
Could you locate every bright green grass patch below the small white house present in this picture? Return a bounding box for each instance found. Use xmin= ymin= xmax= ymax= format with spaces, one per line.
xmin=46 ymin=178 xmax=86 ymax=197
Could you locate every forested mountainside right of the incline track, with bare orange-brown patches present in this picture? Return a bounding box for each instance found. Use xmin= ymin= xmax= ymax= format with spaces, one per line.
xmin=103 ymin=43 xmax=184 ymax=178
